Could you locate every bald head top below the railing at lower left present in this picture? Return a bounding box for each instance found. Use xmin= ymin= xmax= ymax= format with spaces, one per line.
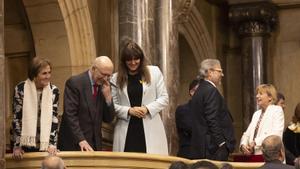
xmin=42 ymin=156 xmax=65 ymax=169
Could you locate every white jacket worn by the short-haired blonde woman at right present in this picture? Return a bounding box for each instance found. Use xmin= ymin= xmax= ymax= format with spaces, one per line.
xmin=240 ymin=105 xmax=284 ymax=154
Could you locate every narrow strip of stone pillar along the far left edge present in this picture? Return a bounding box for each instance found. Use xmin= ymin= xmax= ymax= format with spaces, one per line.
xmin=0 ymin=0 xmax=6 ymax=168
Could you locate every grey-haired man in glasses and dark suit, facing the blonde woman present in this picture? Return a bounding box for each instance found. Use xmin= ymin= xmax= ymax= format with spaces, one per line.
xmin=191 ymin=59 xmax=235 ymax=161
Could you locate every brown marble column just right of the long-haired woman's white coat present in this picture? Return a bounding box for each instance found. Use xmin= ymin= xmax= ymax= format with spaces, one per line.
xmin=156 ymin=0 xmax=194 ymax=155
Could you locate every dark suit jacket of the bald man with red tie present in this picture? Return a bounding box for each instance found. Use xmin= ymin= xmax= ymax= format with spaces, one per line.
xmin=58 ymin=71 xmax=114 ymax=151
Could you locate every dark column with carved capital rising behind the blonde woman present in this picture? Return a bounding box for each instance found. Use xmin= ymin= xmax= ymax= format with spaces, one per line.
xmin=229 ymin=2 xmax=278 ymax=128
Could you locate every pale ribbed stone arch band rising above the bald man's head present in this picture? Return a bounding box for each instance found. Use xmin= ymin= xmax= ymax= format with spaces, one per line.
xmin=58 ymin=0 xmax=96 ymax=73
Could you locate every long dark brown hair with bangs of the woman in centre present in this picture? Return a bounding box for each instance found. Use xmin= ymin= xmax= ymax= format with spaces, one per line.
xmin=117 ymin=41 xmax=151 ymax=88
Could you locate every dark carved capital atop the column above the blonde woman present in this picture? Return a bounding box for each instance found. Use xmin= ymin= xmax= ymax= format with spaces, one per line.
xmin=228 ymin=2 xmax=278 ymax=36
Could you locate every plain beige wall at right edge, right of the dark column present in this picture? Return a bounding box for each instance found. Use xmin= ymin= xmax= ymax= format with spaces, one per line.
xmin=271 ymin=8 xmax=300 ymax=124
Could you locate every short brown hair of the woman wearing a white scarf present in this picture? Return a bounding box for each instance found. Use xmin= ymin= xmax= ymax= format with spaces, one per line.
xmin=28 ymin=57 xmax=52 ymax=80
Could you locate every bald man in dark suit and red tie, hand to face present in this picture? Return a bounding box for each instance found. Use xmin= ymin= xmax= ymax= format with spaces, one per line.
xmin=58 ymin=56 xmax=114 ymax=151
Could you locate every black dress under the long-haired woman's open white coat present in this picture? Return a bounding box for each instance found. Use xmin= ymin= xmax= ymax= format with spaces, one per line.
xmin=124 ymin=74 xmax=146 ymax=153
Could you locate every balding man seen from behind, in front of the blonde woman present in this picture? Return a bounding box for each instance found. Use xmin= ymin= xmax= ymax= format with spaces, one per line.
xmin=259 ymin=135 xmax=295 ymax=169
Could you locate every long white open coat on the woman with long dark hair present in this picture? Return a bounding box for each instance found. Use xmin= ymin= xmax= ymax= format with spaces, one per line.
xmin=112 ymin=66 xmax=169 ymax=155
